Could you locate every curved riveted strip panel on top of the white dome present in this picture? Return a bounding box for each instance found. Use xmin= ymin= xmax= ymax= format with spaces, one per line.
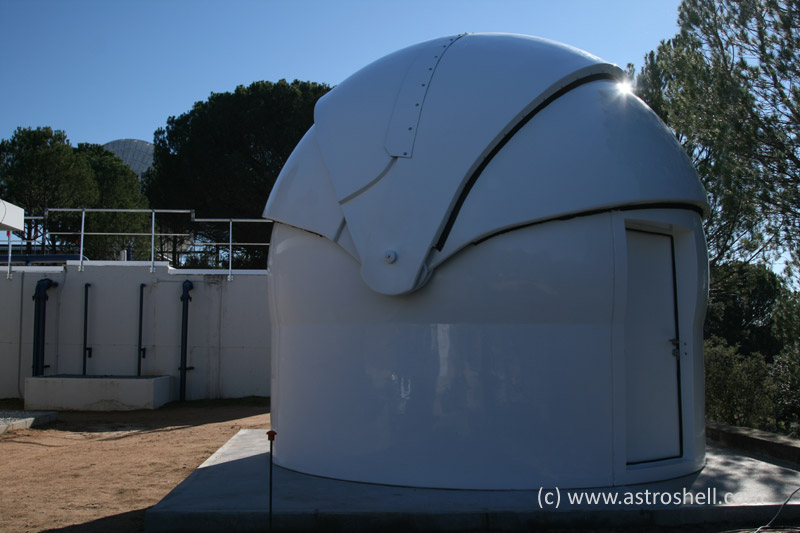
xmin=386 ymin=35 xmax=462 ymax=157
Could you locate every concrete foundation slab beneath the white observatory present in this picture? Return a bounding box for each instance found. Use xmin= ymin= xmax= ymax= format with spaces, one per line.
xmin=145 ymin=430 xmax=800 ymax=532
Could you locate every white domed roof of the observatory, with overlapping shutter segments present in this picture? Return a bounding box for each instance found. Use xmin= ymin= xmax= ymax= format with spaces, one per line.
xmin=264 ymin=34 xmax=708 ymax=295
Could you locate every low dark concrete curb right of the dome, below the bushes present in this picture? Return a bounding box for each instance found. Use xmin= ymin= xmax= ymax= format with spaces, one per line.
xmin=706 ymin=422 xmax=800 ymax=465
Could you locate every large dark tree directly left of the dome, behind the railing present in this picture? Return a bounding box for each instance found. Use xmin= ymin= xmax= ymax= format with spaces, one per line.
xmin=144 ymin=80 xmax=330 ymax=268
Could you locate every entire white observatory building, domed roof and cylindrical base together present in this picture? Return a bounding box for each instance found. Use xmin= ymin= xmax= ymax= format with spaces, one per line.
xmin=264 ymin=34 xmax=708 ymax=489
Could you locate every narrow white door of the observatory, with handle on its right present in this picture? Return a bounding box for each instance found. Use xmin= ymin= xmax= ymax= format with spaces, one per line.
xmin=625 ymin=230 xmax=682 ymax=464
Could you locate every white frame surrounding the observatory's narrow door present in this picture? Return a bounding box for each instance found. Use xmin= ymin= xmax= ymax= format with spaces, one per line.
xmin=611 ymin=209 xmax=708 ymax=485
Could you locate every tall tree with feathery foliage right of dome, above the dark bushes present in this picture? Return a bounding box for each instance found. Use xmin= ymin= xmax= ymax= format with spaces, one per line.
xmin=636 ymin=0 xmax=800 ymax=268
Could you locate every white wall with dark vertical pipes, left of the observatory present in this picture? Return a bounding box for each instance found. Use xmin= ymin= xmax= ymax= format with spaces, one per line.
xmin=0 ymin=261 xmax=270 ymax=399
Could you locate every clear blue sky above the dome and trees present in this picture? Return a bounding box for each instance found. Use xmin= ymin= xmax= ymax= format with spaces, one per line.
xmin=0 ymin=0 xmax=680 ymax=144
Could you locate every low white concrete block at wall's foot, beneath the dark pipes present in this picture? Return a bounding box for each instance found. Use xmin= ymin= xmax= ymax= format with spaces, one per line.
xmin=25 ymin=375 xmax=172 ymax=411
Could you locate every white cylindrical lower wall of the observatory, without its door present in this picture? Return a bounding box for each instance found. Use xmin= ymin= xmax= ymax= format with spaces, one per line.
xmin=268 ymin=210 xmax=705 ymax=489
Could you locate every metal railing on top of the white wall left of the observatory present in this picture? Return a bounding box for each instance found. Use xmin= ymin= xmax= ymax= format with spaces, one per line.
xmin=6 ymin=208 xmax=272 ymax=281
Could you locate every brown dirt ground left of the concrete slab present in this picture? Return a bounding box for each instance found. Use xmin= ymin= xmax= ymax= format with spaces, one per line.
xmin=0 ymin=398 xmax=270 ymax=533
